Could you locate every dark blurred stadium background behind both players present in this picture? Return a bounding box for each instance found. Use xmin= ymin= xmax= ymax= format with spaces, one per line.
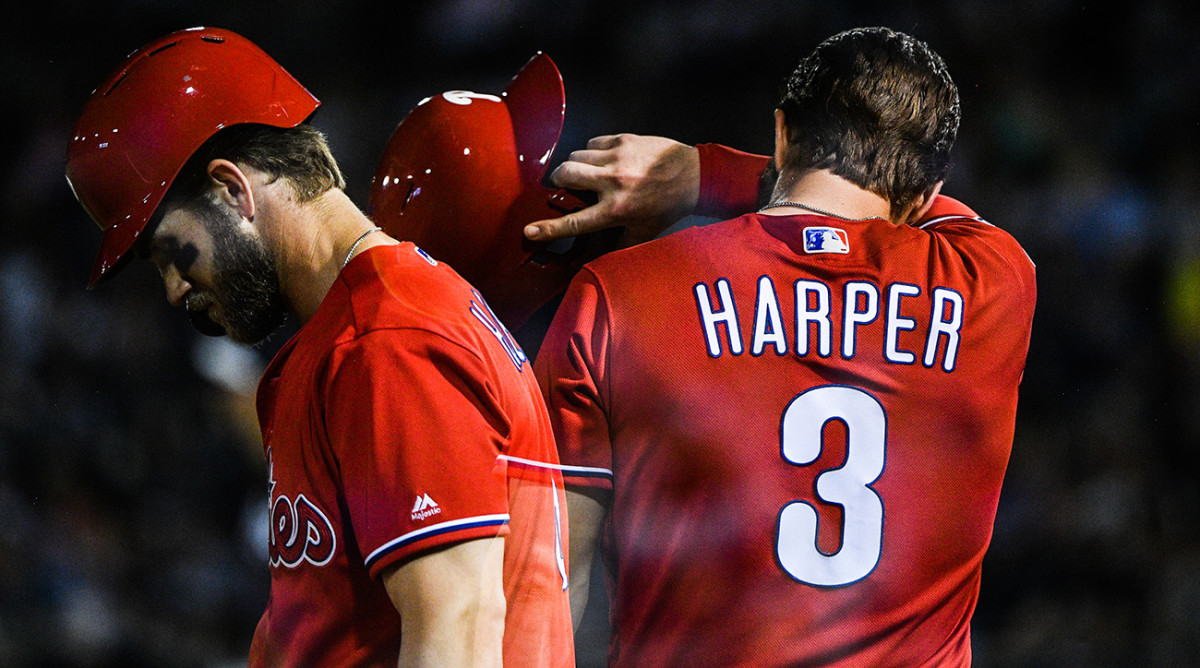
xmin=0 ymin=0 xmax=1200 ymax=667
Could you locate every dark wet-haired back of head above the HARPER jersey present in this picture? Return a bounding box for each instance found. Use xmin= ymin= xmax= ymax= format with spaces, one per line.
xmin=779 ymin=28 xmax=960 ymax=212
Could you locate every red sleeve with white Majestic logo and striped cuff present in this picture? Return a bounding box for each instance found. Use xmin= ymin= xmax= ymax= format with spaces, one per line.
xmin=324 ymin=330 xmax=509 ymax=577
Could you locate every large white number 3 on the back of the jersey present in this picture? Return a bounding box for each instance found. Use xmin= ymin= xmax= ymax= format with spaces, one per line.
xmin=775 ymin=385 xmax=887 ymax=586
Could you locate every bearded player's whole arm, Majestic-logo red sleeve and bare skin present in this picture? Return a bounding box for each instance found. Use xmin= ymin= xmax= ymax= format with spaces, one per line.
xmin=320 ymin=329 xmax=509 ymax=667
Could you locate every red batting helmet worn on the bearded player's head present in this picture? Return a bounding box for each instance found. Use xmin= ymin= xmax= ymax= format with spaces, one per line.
xmin=66 ymin=28 xmax=320 ymax=287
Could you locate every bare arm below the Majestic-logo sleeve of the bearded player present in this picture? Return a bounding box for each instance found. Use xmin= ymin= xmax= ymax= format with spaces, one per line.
xmin=383 ymin=536 xmax=505 ymax=668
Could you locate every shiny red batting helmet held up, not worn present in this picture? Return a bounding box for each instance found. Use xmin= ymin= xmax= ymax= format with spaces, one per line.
xmin=368 ymin=53 xmax=609 ymax=329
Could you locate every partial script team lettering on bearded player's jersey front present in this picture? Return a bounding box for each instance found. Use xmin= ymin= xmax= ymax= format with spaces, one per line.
xmin=266 ymin=450 xmax=337 ymax=568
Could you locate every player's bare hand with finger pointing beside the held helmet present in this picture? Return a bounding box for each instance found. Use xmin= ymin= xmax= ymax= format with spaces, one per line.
xmin=524 ymin=134 xmax=700 ymax=246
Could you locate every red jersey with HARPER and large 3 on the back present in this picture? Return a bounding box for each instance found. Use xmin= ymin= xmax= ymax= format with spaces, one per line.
xmin=536 ymin=206 xmax=1036 ymax=667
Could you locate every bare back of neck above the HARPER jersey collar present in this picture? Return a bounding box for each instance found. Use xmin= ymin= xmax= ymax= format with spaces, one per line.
xmin=762 ymin=169 xmax=892 ymax=219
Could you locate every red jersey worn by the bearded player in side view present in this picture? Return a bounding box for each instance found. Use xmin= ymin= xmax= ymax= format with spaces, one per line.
xmin=250 ymin=243 xmax=574 ymax=667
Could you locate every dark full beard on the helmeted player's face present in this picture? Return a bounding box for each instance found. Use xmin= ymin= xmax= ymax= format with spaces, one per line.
xmin=187 ymin=200 xmax=287 ymax=345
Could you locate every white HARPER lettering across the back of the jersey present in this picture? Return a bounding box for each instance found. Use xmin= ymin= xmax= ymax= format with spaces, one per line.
xmin=694 ymin=275 xmax=965 ymax=372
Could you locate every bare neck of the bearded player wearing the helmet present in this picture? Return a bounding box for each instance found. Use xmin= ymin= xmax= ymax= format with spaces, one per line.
xmin=264 ymin=188 xmax=396 ymax=325
